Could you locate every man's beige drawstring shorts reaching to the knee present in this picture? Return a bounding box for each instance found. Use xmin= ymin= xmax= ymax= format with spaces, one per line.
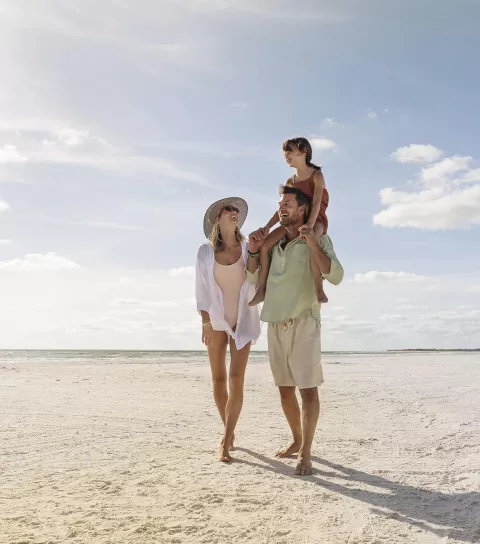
xmin=267 ymin=315 xmax=324 ymax=389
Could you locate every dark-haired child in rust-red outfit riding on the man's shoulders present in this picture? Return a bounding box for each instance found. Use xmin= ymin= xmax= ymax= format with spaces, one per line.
xmin=250 ymin=138 xmax=329 ymax=306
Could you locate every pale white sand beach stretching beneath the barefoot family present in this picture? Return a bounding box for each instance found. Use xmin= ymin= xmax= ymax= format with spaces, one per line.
xmin=0 ymin=354 xmax=480 ymax=544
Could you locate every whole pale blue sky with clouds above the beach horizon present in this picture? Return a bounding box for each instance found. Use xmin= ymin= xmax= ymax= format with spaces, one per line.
xmin=0 ymin=0 xmax=480 ymax=351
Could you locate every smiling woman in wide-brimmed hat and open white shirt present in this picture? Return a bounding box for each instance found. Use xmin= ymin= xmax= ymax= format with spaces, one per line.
xmin=196 ymin=197 xmax=260 ymax=463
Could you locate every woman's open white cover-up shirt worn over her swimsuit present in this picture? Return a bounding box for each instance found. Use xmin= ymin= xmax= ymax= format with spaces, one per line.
xmin=195 ymin=242 xmax=261 ymax=349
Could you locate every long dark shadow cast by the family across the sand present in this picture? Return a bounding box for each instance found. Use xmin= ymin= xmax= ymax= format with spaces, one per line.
xmin=235 ymin=448 xmax=480 ymax=544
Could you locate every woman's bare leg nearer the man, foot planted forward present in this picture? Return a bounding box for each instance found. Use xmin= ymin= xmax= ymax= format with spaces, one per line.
xmin=219 ymin=339 xmax=250 ymax=463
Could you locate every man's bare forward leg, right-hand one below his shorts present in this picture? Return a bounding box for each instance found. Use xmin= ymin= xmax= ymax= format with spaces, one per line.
xmin=295 ymin=387 xmax=320 ymax=476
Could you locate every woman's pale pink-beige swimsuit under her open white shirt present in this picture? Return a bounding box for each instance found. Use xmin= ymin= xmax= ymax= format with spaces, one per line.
xmin=213 ymin=255 xmax=245 ymax=329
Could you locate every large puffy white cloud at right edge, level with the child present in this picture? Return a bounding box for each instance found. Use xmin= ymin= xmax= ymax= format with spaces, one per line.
xmin=373 ymin=148 xmax=480 ymax=230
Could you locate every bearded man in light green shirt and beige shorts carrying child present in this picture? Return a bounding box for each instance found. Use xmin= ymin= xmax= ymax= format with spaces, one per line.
xmin=247 ymin=185 xmax=343 ymax=475
